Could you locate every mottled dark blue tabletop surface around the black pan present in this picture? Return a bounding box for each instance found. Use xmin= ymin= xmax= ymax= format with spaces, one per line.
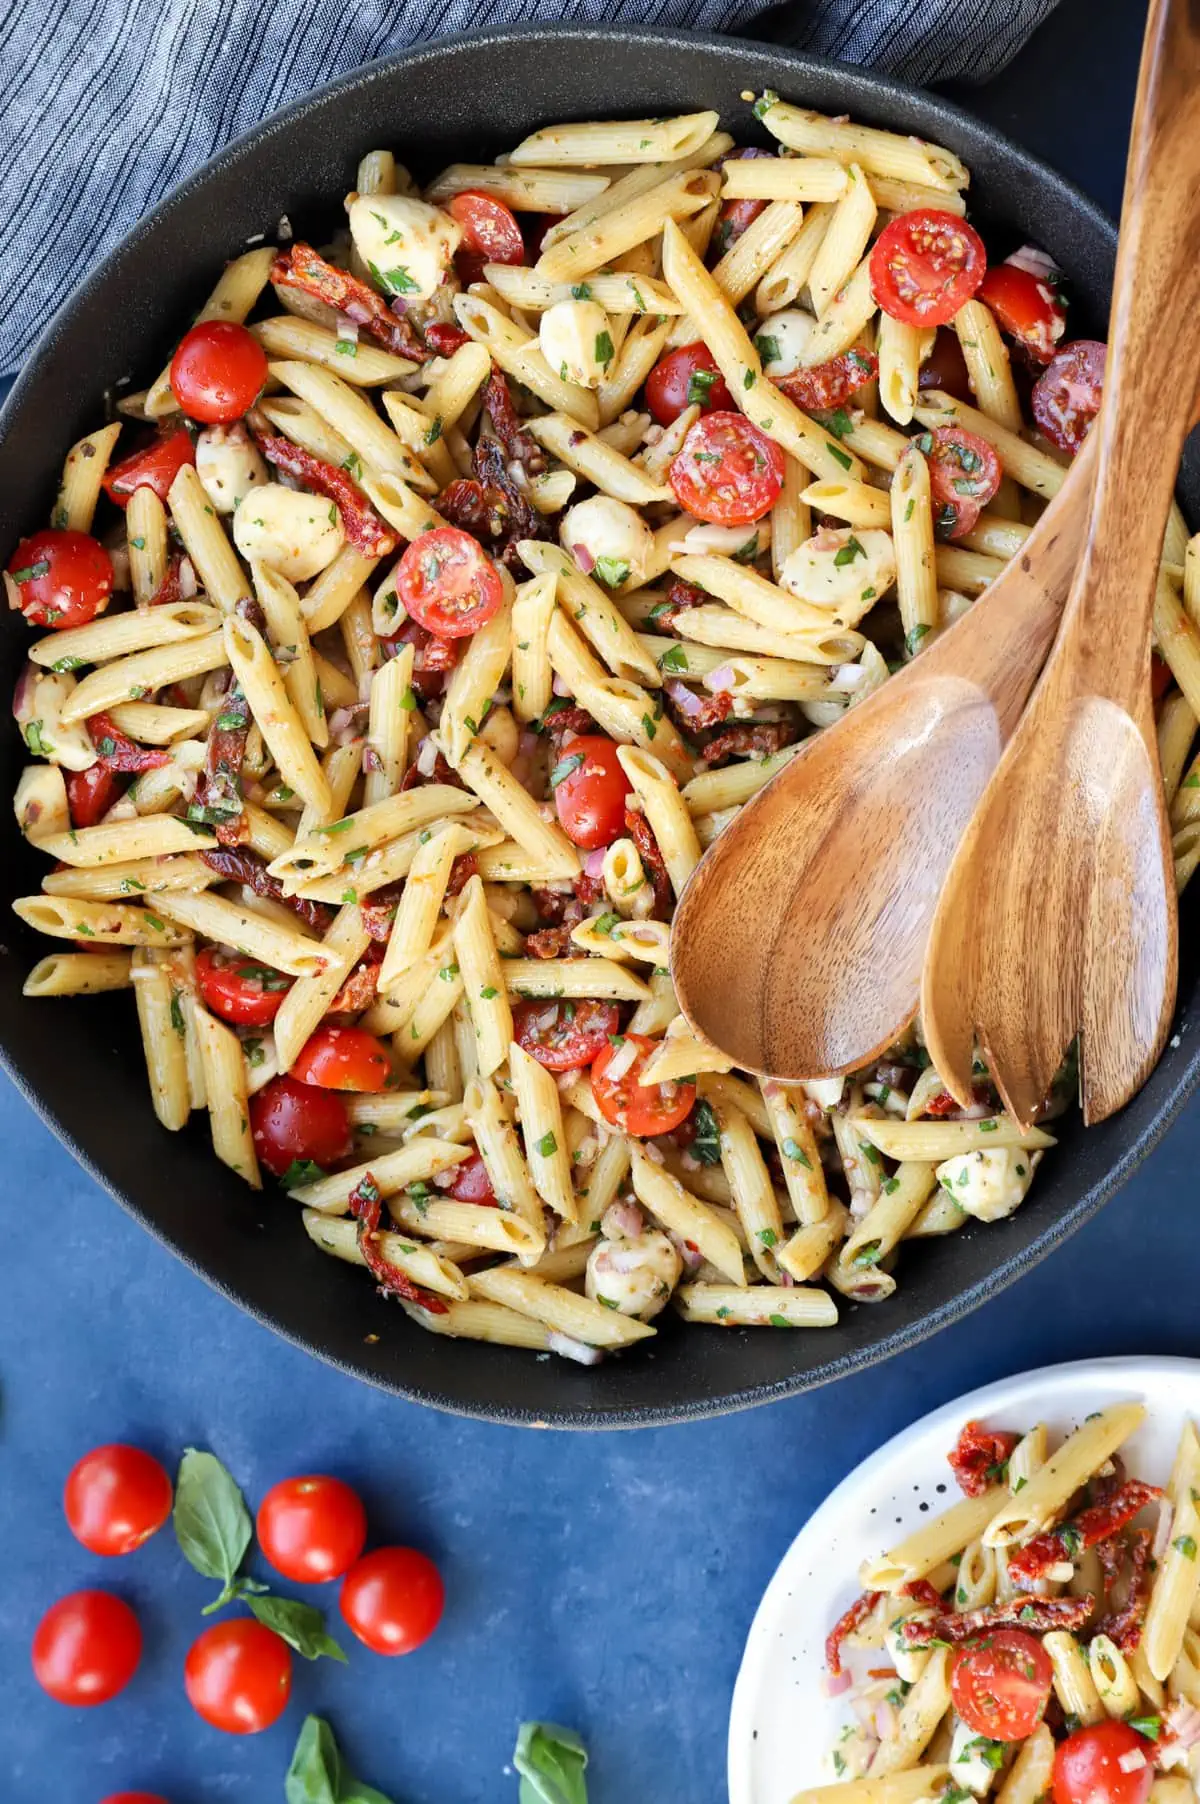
xmin=0 ymin=0 xmax=1176 ymax=1804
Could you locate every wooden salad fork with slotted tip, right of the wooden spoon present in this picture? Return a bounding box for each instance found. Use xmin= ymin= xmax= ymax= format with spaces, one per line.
xmin=920 ymin=0 xmax=1200 ymax=1126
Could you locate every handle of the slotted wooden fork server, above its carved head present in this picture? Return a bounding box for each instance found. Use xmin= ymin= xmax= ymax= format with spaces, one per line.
xmin=1066 ymin=0 xmax=1200 ymax=681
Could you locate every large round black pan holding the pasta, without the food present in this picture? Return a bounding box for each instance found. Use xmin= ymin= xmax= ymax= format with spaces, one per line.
xmin=0 ymin=29 xmax=1200 ymax=1427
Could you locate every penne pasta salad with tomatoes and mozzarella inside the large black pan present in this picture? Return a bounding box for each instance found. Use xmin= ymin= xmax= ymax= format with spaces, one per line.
xmin=0 ymin=45 xmax=1200 ymax=1407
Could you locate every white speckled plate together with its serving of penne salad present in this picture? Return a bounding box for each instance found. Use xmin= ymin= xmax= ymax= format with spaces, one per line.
xmin=729 ymin=1358 xmax=1200 ymax=1804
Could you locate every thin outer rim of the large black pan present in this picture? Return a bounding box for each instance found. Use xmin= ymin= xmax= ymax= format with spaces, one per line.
xmin=0 ymin=22 xmax=1200 ymax=1431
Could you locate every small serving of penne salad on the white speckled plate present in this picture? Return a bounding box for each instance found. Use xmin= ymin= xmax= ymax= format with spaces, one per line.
xmin=815 ymin=1404 xmax=1200 ymax=1804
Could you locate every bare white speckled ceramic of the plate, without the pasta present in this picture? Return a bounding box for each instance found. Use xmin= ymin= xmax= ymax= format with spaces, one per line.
xmin=729 ymin=1358 xmax=1200 ymax=1804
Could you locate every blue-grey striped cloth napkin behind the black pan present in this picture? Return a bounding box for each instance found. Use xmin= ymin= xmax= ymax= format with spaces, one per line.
xmin=0 ymin=0 xmax=1054 ymax=372
